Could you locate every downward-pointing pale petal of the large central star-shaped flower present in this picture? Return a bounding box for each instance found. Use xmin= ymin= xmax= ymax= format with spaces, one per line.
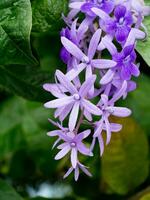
xmin=69 ymin=101 xmax=80 ymax=131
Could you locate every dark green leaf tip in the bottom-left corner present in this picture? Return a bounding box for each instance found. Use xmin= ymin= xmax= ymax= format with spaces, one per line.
xmin=0 ymin=180 xmax=23 ymax=200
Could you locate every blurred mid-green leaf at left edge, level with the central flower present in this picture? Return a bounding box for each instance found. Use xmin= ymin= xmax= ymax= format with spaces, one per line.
xmin=0 ymin=97 xmax=52 ymax=158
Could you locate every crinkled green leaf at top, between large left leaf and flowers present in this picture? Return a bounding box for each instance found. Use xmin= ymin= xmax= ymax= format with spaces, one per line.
xmin=32 ymin=0 xmax=68 ymax=34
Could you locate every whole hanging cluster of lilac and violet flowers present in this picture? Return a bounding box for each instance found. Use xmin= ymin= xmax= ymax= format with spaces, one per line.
xmin=43 ymin=0 xmax=150 ymax=180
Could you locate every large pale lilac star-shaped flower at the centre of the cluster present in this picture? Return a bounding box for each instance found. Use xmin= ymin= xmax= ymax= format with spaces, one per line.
xmin=44 ymin=70 xmax=101 ymax=131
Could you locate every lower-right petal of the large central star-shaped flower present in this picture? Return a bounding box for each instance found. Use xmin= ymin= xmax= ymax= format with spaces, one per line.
xmin=82 ymin=99 xmax=102 ymax=115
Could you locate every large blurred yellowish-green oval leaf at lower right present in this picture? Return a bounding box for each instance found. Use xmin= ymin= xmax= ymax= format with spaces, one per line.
xmin=102 ymin=118 xmax=149 ymax=194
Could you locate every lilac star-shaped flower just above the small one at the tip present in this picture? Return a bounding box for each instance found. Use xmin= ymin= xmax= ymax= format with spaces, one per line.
xmin=48 ymin=130 xmax=92 ymax=168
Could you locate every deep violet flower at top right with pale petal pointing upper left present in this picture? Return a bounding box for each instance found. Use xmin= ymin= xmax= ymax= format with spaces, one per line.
xmin=92 ymin=5 xmax=133 ymax=43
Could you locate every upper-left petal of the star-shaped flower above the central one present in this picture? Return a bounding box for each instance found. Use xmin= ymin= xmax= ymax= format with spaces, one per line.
xmin=61 ymin=37 xmax=86 ymax=61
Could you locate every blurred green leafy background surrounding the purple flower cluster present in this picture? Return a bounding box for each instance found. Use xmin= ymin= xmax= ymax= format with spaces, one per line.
xmin=0 ymin=0 xmax=150 ymax=200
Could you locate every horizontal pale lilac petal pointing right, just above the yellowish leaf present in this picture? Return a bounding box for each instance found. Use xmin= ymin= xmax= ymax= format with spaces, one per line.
xmin=107 ymin=106 xmax=131 ymax=117
